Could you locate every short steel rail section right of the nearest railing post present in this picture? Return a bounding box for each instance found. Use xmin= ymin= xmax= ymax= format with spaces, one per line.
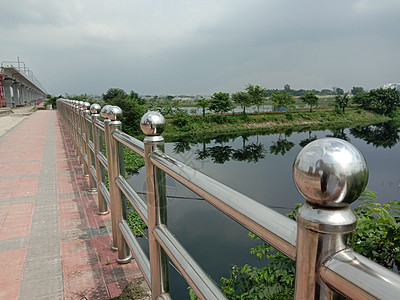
xmin=320 ymin=250 xmax=400 ymax=300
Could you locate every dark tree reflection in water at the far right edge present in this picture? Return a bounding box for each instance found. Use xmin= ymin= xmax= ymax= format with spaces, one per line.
xmin=350 ymin=122 xmax=400 ymax=148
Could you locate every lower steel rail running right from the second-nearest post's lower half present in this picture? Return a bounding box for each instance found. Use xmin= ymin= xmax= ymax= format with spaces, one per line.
xmin=154 ymin=225 xmax=227 ymax=300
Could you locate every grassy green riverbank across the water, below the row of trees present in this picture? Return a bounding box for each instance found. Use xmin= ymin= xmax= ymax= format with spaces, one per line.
xmin=163 ymin=109 xmax=398 ymax=141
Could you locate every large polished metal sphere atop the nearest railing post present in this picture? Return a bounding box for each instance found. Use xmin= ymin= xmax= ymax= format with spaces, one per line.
xmin=293 ymin=138 xmax=368 ymax=207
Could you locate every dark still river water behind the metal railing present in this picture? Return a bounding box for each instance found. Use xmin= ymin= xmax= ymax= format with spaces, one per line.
xmin=129 ymin=123 xmax=400 ymax=299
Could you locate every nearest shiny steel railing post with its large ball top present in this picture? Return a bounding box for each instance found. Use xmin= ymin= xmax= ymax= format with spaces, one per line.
xmin=293 ymin=138 xmax=368 ymax=299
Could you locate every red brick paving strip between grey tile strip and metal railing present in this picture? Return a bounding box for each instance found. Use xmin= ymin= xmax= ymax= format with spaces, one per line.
xmin=56 ymin=112 xmax=142 ymax=299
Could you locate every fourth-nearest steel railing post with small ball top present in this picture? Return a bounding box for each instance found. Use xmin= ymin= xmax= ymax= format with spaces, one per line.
xmin=90 ymin=103 xmax=109 ymax=215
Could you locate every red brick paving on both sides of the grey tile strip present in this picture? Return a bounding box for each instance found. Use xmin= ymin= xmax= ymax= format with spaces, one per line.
xmin=0 ymin=111 xmax=146 ymax=300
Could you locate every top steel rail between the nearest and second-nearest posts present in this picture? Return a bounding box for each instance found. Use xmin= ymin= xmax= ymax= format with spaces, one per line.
xmin=150 ymin=152 xmax=297 ymax=259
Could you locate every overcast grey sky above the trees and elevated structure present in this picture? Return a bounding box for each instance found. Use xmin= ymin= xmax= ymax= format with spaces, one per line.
xmin=0 ymin=0 xmax=400 ymax=95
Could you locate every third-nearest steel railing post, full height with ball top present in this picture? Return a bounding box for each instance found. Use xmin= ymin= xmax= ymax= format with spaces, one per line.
xmin=105 ymin=106 xmax=132 ymax=264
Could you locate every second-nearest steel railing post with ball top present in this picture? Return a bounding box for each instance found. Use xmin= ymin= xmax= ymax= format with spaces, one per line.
xmin=140 ymin=111 xmax=169 ymax=299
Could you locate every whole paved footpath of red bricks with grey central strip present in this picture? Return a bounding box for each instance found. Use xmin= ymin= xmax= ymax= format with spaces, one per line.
xmin=0 ymin=110 xmax=146 ymax=300
